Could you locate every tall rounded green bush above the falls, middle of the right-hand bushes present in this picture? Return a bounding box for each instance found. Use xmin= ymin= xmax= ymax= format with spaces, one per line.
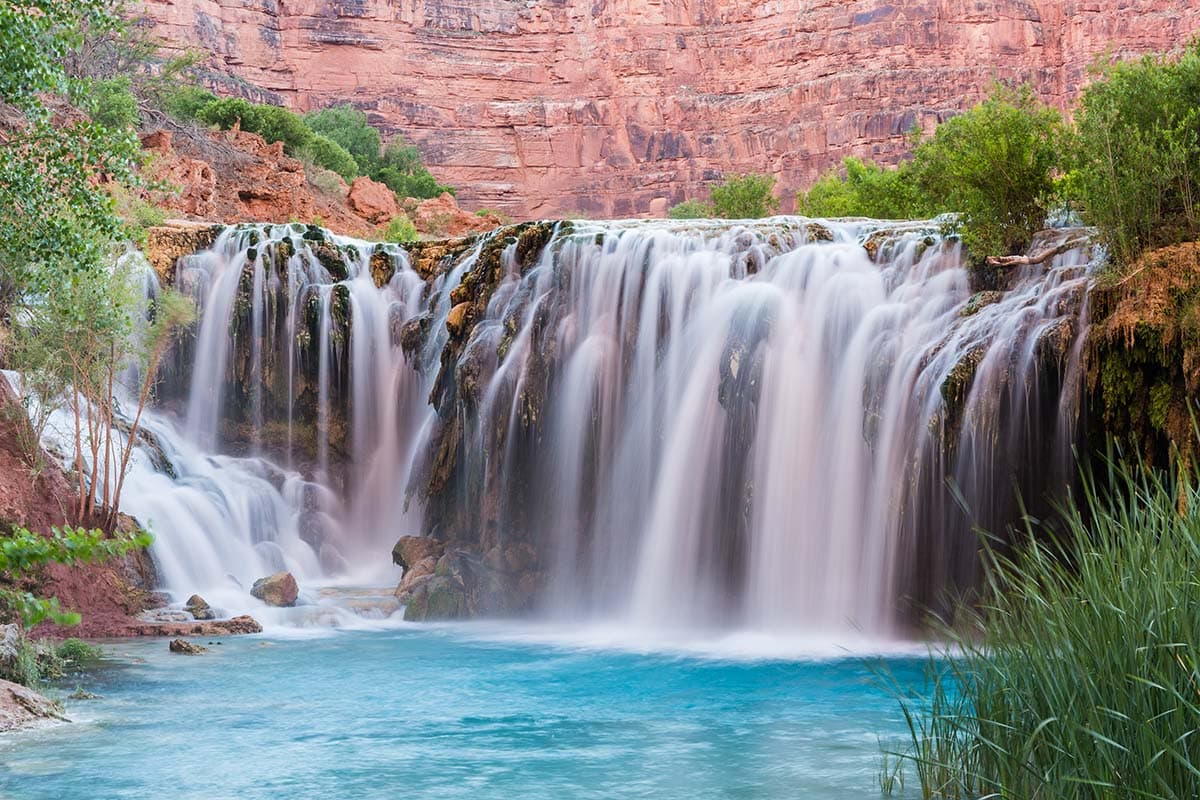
xmin=912 ymin=86 xmax=1064 ymax=258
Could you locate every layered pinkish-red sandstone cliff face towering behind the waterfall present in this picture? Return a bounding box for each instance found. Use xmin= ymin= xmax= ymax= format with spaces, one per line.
xmin=145 ymin=0 xmax=1200 ymax=218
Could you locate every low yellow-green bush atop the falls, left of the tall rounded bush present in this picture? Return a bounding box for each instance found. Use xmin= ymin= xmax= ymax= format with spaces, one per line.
xmin=796 ymin=158 xmax=934 ymax=219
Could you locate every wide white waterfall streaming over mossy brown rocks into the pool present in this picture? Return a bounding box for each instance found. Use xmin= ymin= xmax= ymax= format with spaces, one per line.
xmin=128 ymin=217 xmax=1096 ymax=634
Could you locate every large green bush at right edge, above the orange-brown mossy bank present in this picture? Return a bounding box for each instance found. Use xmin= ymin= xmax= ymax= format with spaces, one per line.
xmin=1069 ymin=41 xmax=1200 ymax=264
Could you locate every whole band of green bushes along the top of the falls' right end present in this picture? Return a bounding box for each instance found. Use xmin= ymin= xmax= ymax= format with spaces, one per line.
xmin=797 ymin=42 xmax=1200 ymax=271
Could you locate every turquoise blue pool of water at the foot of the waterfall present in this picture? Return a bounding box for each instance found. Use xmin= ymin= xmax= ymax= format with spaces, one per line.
xmin=0 ymin=626 xmax=923 ymax=800
